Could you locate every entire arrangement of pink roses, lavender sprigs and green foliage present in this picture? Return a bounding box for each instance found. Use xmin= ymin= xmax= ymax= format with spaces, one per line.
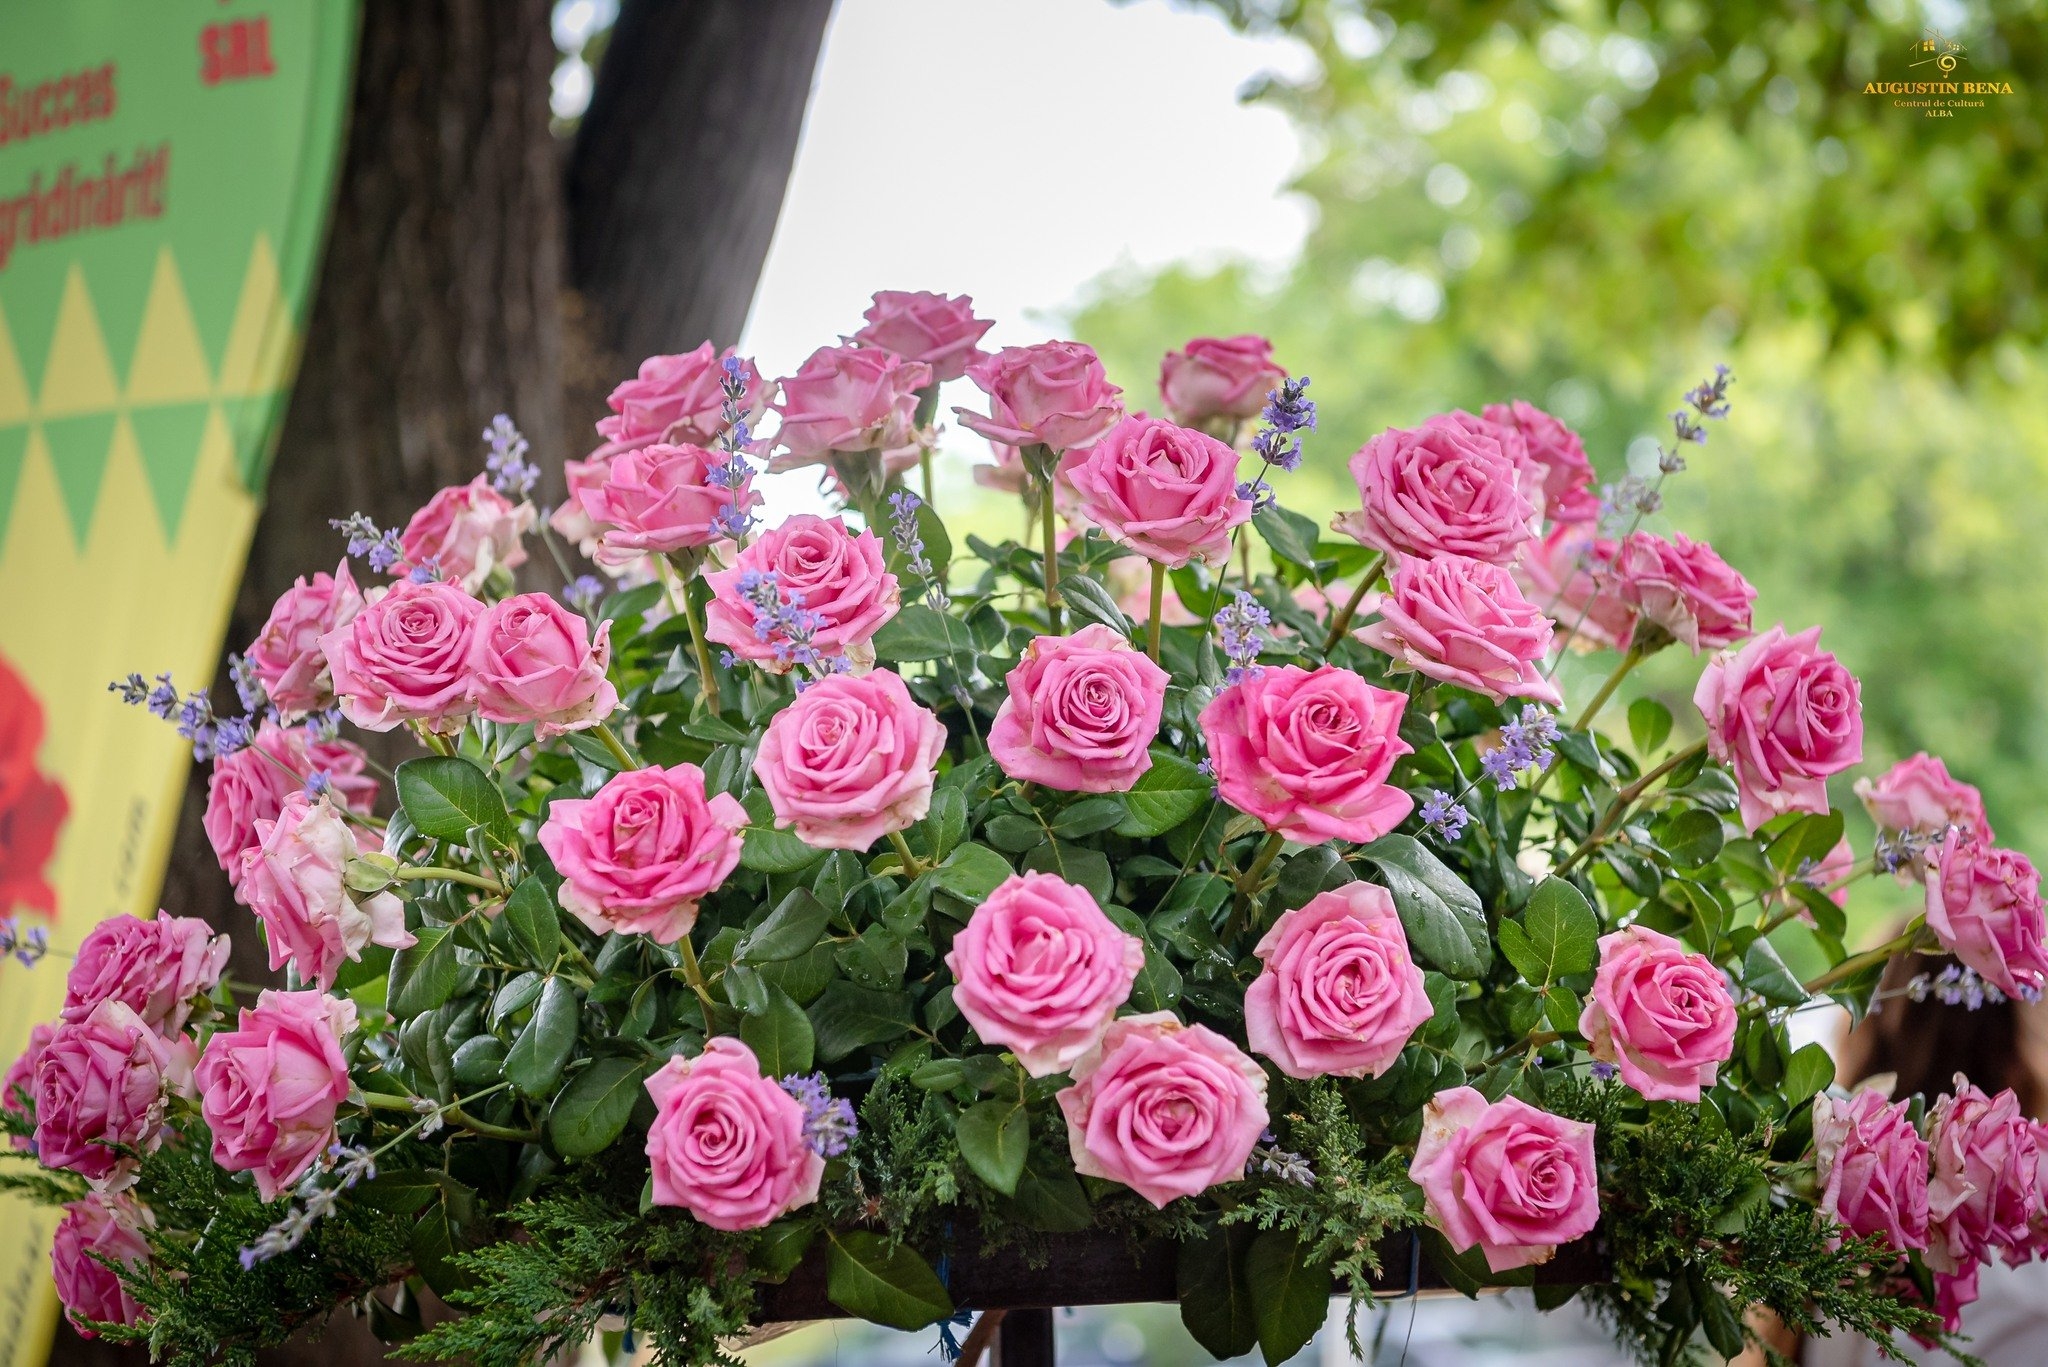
xmin=0 ymin=293 xmax=2048 ymax=1367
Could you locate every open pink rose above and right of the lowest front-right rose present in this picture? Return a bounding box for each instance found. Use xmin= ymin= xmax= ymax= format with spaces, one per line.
xmin=1579 ymin=926 xmax=1735 ymax=1103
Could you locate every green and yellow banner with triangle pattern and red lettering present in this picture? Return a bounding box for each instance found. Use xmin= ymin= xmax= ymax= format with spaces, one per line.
xmin=0 ymin=0 xmax=356 ymax=1367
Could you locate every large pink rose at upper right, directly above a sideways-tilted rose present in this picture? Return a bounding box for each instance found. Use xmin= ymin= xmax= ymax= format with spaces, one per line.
xmin=1331 ymin=414 xmax=1536 ymax=566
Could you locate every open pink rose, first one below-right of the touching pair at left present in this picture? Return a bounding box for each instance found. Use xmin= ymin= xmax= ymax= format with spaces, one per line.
xmin=541 ymin=764 xmax=748 ymax=945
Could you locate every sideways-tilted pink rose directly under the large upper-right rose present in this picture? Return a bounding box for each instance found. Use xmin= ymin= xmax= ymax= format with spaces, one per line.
xmin=1356 ymin=555 xmax=1565 ymax=707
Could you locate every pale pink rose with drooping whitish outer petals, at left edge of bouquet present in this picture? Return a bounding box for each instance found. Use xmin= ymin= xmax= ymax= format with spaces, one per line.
xmin=240 ymin=793 xmax=418 ymax=990
